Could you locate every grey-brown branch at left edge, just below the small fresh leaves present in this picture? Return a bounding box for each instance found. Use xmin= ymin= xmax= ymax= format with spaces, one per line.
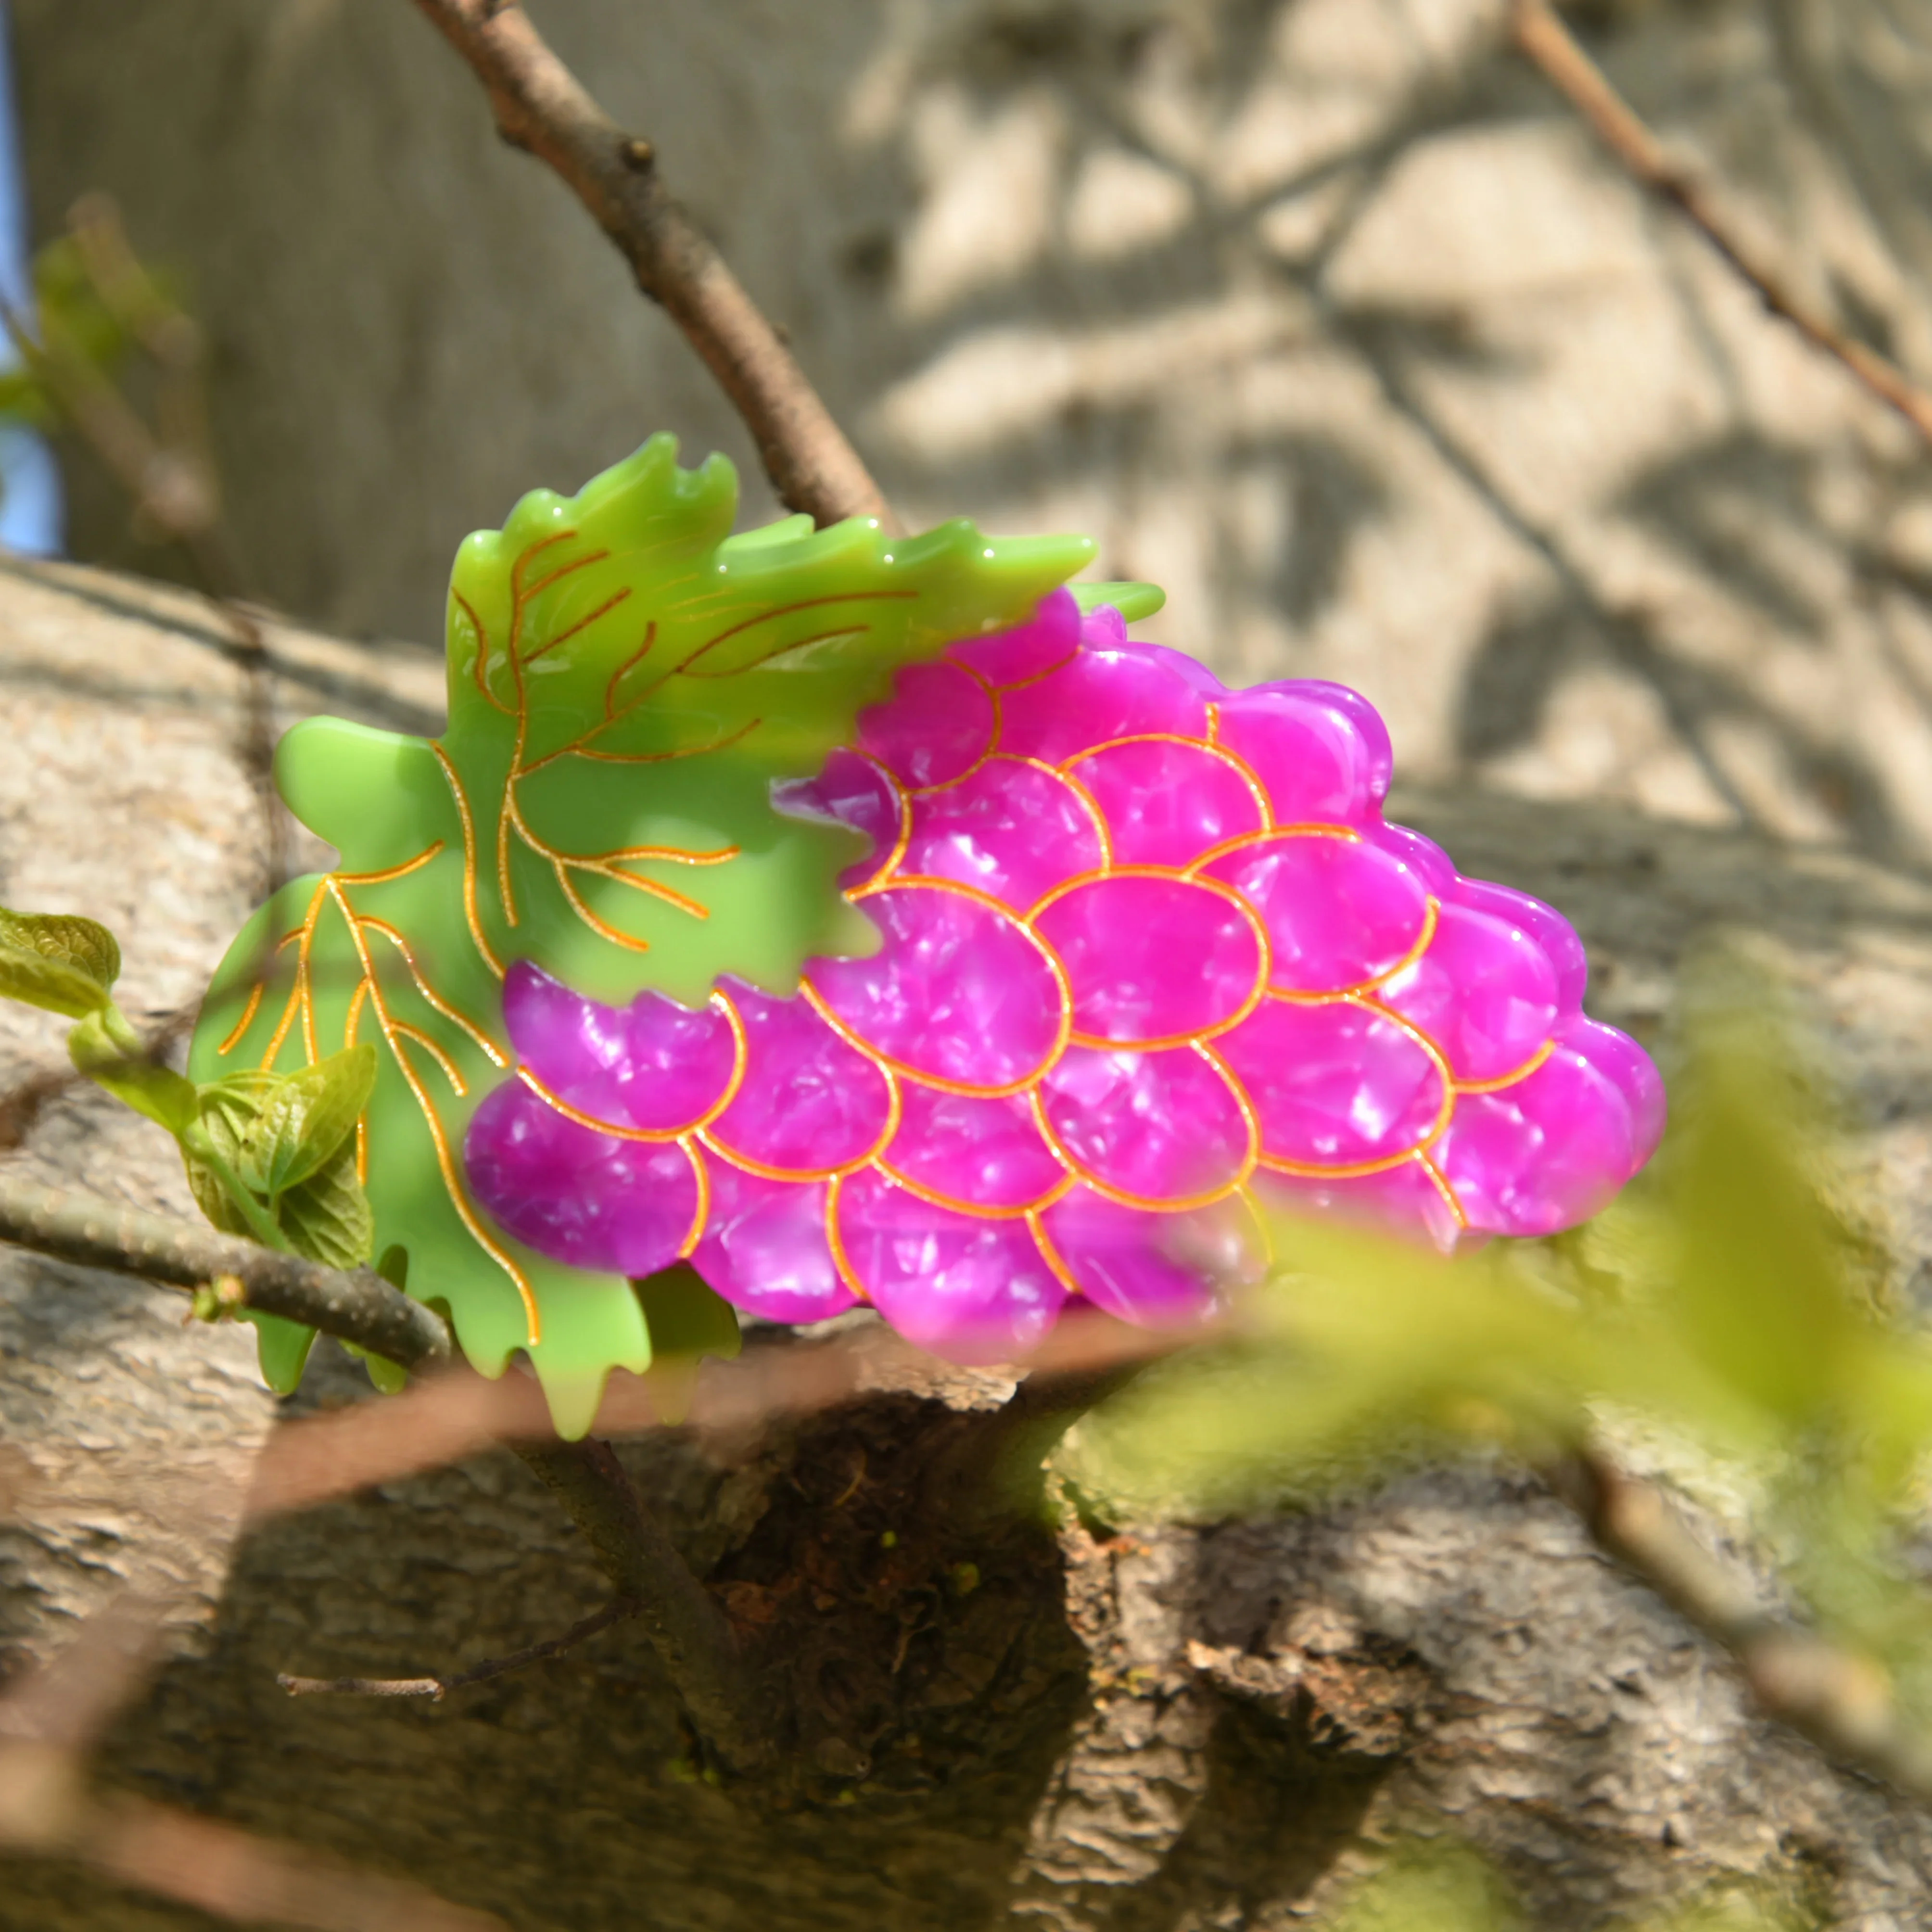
xmin=0 ymin=1173 xmax=454 ymax=1370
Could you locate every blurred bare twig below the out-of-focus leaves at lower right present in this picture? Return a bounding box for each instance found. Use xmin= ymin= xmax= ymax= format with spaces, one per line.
xmin=1550 ymin=1449 xmax=1932 ymax=1805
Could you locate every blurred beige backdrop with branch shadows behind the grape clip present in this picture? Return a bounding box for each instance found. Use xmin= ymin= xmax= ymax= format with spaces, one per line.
xmin=13 ymin=0 xmax=1932 ymax=864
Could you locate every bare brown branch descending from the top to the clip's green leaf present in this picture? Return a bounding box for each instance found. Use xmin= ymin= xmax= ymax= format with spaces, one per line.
xmin=415 ymin=0 xmax=894 ymax=527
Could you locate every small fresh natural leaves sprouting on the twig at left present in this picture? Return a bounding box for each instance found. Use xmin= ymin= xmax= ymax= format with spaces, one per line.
xmin=0 ymin=908 xmax=400 ymax=1381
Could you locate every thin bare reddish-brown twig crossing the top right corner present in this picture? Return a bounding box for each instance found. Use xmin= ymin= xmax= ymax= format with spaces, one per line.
xmin=1511 ymin=0 xmax=1932 ymax=443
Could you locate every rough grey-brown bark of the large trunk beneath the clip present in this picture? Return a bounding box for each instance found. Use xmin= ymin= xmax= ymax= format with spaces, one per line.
xmin=11 ymin=568 xmax=1932 ymax=1932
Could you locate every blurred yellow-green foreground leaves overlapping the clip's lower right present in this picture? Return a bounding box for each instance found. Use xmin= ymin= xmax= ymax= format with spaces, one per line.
xmin=1081 ymin=974 xmax=1932 ymax=1729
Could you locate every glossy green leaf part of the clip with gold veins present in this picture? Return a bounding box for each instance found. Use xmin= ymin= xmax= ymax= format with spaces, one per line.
xmin=190 ymin=437 xmax=1093 ymax=1434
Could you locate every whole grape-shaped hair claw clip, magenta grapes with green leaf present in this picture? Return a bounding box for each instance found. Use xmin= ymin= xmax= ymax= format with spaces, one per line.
xmin=190 ymin=437 xmax=1664 ymax=1434
